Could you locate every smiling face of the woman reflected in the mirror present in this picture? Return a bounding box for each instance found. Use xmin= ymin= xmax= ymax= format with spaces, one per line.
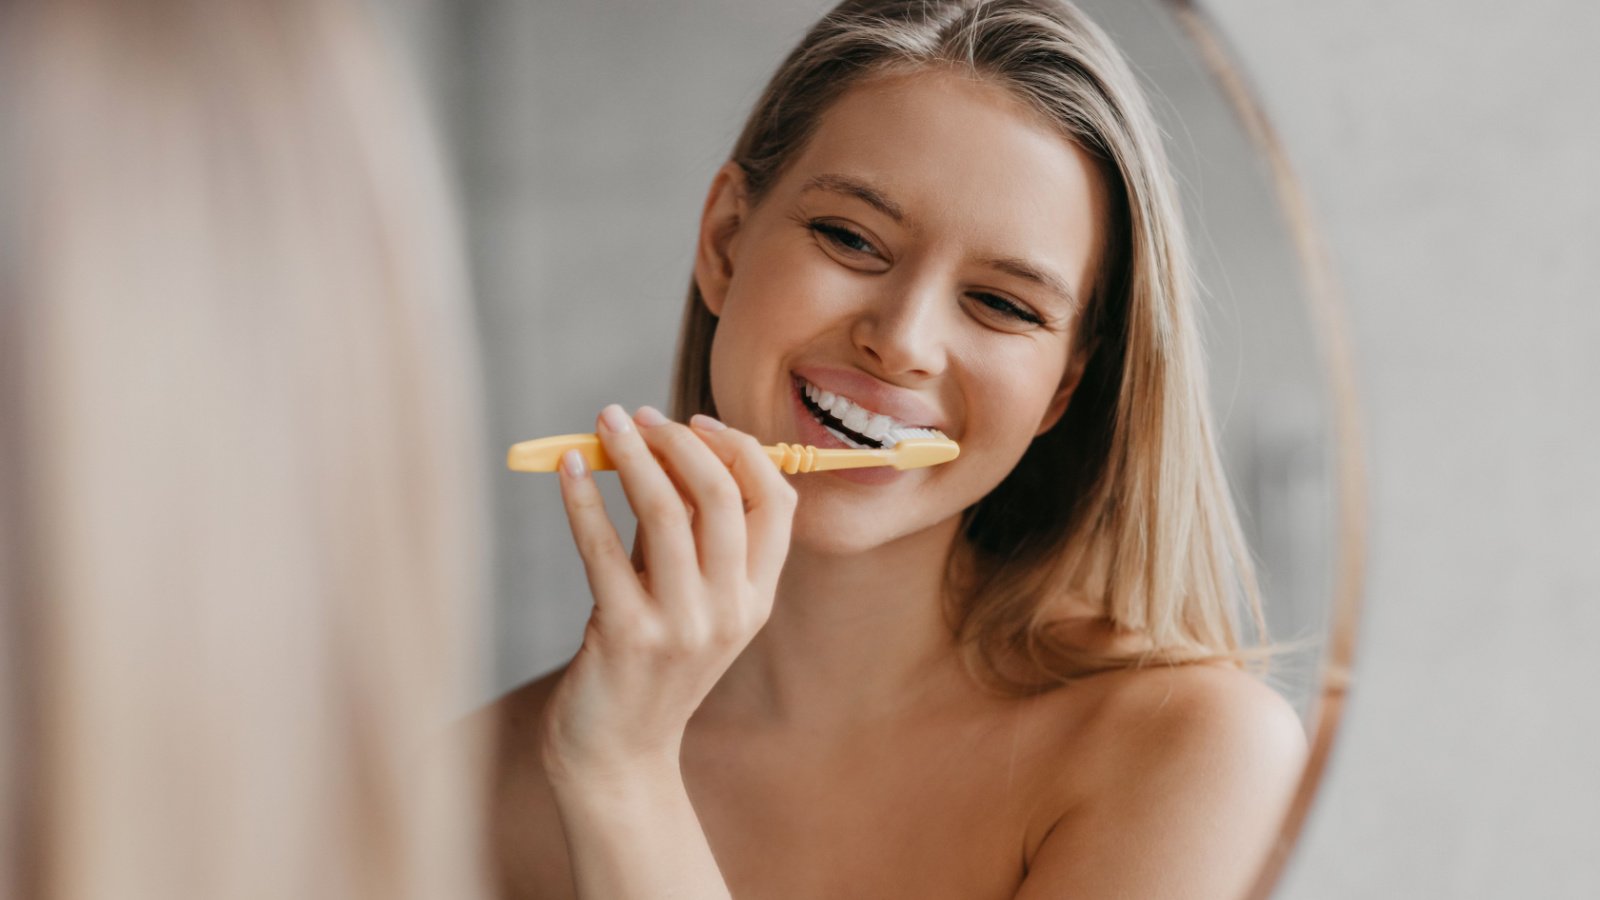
xmin=696 ymin=70 xmax=1104 ymax=552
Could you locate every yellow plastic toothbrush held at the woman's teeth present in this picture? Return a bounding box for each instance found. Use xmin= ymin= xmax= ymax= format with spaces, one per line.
xmin=506 ymin=429 xmax=962 ymax=476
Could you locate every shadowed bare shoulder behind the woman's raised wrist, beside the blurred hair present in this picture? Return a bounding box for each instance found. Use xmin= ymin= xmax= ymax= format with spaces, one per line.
xmin=474 ymin=666 xmax=573 ymax=900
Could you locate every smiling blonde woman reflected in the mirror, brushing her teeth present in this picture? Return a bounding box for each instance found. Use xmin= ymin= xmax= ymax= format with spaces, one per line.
xmin=496 ymin=0 xmax=1304 ymax=898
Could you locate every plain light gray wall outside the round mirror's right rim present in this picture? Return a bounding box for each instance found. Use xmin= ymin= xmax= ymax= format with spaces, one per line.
xmin=1206 ymin=0 xmax=1600 ymax=900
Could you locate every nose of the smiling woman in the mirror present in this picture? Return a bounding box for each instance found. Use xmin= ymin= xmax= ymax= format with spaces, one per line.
xmin=850 ymin=269 xmax=949 ymax=378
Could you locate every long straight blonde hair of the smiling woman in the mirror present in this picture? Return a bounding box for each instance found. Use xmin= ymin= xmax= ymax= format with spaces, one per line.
xmin=674 ymin=0 xmax=1266 ymax=692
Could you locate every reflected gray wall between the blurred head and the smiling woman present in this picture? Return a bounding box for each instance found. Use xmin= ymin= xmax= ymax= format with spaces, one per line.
xmin=440 ymin=0 xmax=822 ymax=697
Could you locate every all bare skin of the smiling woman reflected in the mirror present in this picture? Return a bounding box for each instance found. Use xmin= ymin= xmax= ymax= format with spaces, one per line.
xmin=488 ymin=72 xmax=1304 ymax=900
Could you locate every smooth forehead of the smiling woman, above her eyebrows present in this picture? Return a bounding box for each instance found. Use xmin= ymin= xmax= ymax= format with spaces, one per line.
xmin=779 ymin=70 xmax=1104 ymax=280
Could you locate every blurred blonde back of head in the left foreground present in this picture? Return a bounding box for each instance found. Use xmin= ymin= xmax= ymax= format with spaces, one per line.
xmin=0 ymin=0 xmax=483 ymax=900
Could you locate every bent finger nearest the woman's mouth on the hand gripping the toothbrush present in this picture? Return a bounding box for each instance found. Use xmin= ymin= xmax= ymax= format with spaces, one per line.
xmin=690 ymin=408 xmax=797 ymax=589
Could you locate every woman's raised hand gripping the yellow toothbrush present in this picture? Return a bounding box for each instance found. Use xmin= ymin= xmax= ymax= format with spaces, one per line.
xmin=541 ymin=405 xmax=795 ymax=781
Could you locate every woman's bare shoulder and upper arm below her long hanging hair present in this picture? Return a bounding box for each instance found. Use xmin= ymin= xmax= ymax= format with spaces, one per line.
xmin=1019 ymin=665 xmax=1306 ymax=900
